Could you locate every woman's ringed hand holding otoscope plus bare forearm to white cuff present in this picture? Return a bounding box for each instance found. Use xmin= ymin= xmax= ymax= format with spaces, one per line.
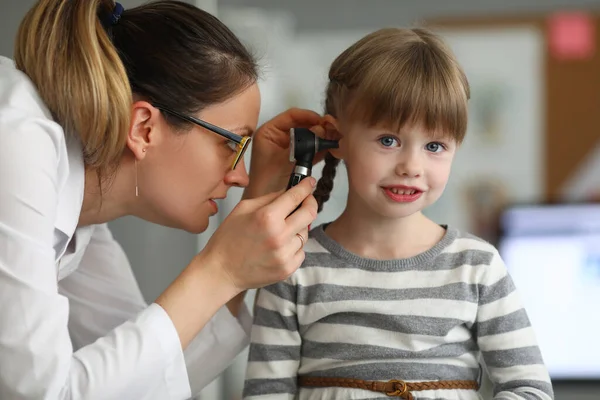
xmin=155 ymin=177 xmax=317 ymax=349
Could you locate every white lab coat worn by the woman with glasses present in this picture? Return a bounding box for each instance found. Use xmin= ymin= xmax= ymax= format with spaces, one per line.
xmin=0 ymin=57 xmax=251 ymax=400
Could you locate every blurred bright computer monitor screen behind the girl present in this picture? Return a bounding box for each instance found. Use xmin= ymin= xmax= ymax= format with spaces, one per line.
xmin=498 ymin=204 xmax=600 ymax=380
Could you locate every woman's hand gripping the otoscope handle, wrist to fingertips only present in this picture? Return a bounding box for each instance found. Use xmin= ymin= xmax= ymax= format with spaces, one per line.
xmin=196 ymin=177 xmax=317 ymax=292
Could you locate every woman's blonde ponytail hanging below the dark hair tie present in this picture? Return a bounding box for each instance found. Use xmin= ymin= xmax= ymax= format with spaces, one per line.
xmin=14 ymin=0 xmax=132 ymax=173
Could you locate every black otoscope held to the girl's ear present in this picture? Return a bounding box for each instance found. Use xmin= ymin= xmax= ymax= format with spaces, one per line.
xmin=287 ymin=128 xmax=338 ymax=189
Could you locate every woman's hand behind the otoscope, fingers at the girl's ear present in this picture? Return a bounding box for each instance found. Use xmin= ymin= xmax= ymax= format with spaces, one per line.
xmin=243 ymin=108 xmax=322 ymax=199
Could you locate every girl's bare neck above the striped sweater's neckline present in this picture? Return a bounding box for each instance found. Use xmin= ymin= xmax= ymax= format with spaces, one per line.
xmin=326 ymin=197 xmax=445 ymax=260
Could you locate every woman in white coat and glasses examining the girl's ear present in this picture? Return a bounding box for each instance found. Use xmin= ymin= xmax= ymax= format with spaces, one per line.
xmin=0 ymin=0 xmax=319 ymax=400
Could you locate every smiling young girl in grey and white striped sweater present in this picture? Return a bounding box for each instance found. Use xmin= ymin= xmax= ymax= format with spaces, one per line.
xmin=244 ymin=29 xmax=553 ymax=400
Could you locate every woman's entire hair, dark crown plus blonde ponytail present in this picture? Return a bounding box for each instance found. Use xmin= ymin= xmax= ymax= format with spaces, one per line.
xmin=14 ymin=0 xmax=258 ymax=177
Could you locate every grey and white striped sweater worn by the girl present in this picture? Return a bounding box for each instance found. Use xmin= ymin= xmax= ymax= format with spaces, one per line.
xmin=244 ymin=226 xmax=553 ymax=400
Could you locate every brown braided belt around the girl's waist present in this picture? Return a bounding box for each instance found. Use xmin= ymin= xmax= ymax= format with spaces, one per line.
xmin=298 ymin=376 xmax=479 ymax=400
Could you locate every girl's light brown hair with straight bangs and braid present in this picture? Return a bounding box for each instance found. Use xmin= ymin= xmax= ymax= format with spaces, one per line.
xmin=315 ymin=28 xmax=470 ymax=211
